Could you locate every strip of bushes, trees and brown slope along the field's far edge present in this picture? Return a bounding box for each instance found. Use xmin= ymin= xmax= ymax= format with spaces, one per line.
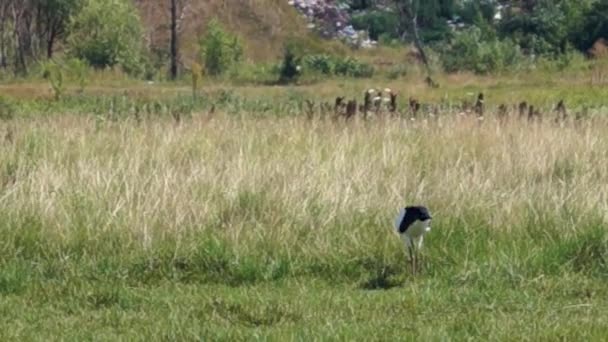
xmin=0 ymin=0 xmax=608 ymax=82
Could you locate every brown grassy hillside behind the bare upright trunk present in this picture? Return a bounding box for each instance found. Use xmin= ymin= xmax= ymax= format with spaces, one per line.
xmin=135 ymin=0 xmax=310 ymax=62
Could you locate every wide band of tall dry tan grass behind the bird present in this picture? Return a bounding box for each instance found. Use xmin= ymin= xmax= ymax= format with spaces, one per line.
xmin=0 ymin=115 xmax=608 ymax=252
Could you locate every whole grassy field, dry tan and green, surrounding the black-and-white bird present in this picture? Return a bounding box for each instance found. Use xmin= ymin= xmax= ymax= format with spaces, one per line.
xmin=0 ymin=73 xmax=608 ymax=341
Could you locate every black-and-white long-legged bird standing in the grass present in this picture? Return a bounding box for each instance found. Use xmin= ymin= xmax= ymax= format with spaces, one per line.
xmin=394 ymin=205 xmax=432 ymax=275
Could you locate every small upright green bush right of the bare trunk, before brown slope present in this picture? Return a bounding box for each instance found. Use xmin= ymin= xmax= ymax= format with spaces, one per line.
xmin=199 ymin=19 xmax=243 ymax=76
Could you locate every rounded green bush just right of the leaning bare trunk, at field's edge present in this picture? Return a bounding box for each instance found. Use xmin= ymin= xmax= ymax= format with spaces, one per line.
xmin=441 ymin=27 xmax=523 ymax=73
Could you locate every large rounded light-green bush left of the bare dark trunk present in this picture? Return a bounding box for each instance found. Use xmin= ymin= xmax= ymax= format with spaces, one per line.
xmin=68 ymin=0 xmax=145 ymax=75
